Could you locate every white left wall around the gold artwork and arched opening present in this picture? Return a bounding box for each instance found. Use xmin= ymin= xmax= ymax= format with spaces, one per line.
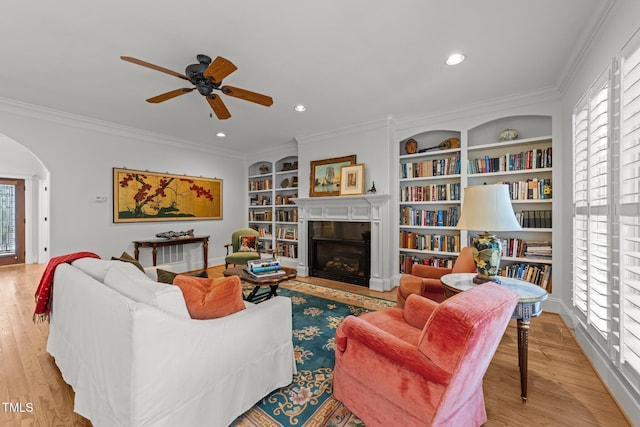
xmin=0 ymin=101 xmax=246 ymax=271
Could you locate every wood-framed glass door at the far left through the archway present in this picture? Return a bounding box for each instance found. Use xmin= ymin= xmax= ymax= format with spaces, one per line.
xmin=0 ymin=178 xmax=25 ymax=265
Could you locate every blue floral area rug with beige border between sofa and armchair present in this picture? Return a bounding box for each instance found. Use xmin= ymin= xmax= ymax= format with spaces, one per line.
xmin=231 ymin=280 xmax=396 ymax=427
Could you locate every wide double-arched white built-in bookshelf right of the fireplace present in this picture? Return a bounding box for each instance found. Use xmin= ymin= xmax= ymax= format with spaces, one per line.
xmin=399 ymin=116 xmax=553 ymax=291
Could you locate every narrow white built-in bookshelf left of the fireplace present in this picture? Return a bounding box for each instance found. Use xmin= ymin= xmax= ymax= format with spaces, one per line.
xmin=248 ymin=156 xmax=298 ymax=259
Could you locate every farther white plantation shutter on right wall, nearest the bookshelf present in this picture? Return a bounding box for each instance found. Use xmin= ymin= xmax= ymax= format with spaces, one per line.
xmin=573 ymin=72 xmax=611 ymax=352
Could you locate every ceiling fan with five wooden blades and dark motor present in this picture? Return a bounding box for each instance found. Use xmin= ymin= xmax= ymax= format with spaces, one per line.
xmin=120 ymin=55 xmax=273 ymax=120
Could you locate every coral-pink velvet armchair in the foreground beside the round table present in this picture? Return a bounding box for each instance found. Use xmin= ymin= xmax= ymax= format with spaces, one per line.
xmin=333 ymin=282 xmax=518 ymax=427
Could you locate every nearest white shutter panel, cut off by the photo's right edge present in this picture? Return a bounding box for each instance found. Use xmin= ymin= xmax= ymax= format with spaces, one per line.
xmin=618 ymin=43 xmax=640 ymax=381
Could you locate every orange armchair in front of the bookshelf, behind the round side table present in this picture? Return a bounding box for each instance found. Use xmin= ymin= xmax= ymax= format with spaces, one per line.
xmin=397 ymin=246 xmax=476 ymax=308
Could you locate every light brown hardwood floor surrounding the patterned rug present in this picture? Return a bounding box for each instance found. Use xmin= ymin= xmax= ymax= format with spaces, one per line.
xmin=0 ymin=265 xmax=631 ymax=427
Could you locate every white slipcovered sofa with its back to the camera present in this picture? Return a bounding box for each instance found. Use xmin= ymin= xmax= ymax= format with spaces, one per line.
xmin=47 ymin=258 xmax=295 ymax=427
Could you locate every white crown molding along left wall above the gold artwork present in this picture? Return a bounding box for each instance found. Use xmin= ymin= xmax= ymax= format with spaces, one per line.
xmin=0 ymin=97 xmax=245 ymax=159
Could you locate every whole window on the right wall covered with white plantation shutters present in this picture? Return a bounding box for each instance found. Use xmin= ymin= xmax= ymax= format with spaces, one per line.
xmin=573 ymin=37 xmax=640 ymax=391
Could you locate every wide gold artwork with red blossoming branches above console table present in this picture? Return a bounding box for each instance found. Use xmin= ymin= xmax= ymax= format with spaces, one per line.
xmin=113 ymin=168 xmax=222 ymax=223
